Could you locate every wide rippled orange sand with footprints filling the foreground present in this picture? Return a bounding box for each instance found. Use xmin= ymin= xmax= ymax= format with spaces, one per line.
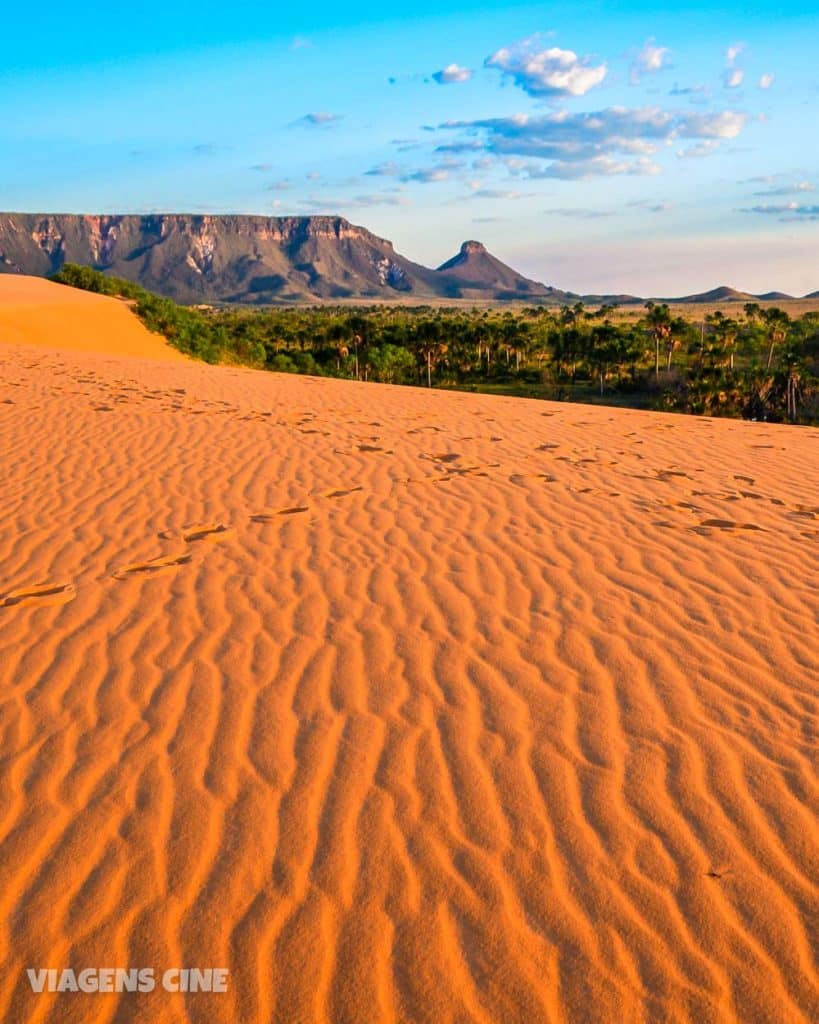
xmin=0 ymin=279 xmax=819 ymax=1024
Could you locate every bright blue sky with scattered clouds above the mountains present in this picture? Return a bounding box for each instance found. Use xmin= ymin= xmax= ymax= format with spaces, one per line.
xmin=0 ymin=0 xmax=819 ymax=294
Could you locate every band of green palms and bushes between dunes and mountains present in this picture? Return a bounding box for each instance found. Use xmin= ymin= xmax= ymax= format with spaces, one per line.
xmin=53 ymin=264 xmax=819 ymax=423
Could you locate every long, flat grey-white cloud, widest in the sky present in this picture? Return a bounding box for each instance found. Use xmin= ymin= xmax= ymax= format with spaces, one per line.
xmin=438 ymin=106 xmax=747 ymax=179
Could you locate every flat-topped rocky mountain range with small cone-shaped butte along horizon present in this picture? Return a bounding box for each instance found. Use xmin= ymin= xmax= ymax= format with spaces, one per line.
xmin=0 ymin=213 xmax=819 ymax=305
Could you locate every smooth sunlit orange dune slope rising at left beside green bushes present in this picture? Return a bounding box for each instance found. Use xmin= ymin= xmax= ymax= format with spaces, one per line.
xmin=0 ymin=273 xmax=184 ymax=361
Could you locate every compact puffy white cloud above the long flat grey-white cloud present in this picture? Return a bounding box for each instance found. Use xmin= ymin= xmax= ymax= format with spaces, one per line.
xmin=484 ymin=39 xmax=608 ymax=99
